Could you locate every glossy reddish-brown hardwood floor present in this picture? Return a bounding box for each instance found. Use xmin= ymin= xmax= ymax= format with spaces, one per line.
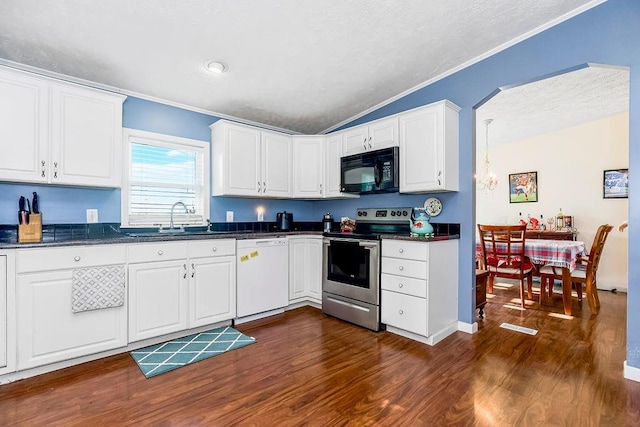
xmin=0 ymin=280 xmax=640 ymax=426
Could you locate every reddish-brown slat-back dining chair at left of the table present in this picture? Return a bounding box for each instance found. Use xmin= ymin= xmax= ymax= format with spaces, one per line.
xmin=478 ymin=224 xmax=533 ymax=308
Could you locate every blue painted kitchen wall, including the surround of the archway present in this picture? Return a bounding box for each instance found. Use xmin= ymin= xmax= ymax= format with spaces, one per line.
xmin=0 ymin=0 xmax=640 ymax=368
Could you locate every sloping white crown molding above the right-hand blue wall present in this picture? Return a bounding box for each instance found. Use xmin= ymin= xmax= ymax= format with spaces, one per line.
xmin=319 ymin=0 xmax=607 ymax=134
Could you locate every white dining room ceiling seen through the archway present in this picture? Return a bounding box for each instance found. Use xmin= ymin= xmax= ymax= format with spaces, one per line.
xmin=476 ymin=64 xmax=629 ymax=149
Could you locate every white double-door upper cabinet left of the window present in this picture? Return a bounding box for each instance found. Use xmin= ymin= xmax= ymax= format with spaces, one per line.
xmin=0 ymin=68 xmax=125 ymax=187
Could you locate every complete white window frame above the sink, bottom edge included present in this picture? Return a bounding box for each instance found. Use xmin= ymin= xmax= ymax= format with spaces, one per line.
xmin=120 ymin=128 xmax=211 ymax=229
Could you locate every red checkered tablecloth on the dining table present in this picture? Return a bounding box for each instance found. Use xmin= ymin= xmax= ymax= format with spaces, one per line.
xmin=476 ymin=239 xmax=585 ymax=271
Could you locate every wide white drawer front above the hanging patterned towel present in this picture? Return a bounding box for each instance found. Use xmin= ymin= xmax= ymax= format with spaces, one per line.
xmin=17 ymin=245 xmax=127 ymax=273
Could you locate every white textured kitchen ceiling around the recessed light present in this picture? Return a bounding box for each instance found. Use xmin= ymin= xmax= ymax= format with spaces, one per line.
xmin=0 ymin=0 xmax=604 ymax=134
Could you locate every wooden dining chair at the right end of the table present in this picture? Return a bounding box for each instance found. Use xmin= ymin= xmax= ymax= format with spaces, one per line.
xmin=540 ymin=224 xmax=613 ymax=314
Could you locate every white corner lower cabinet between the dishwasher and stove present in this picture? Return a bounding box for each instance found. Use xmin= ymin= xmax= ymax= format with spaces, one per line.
xmin=289 ymin=236 xmax=322 ymax=304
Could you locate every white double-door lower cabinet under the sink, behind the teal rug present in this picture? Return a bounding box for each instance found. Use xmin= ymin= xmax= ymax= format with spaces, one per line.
xmin=129 ymin=239 xmax=236 ymax=342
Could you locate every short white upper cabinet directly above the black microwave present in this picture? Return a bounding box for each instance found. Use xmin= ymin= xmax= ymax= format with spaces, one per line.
xmin=342 ymin=116 xmax=398 ymax=156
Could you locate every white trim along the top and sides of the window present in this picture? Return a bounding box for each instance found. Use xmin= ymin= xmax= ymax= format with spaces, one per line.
xmin=120 ymin=128 xmax=211 ymax=228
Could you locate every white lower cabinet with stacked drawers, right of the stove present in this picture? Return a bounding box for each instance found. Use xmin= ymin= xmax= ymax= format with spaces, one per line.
xmin=381 ymin=240 xmax=458 ymax=345
